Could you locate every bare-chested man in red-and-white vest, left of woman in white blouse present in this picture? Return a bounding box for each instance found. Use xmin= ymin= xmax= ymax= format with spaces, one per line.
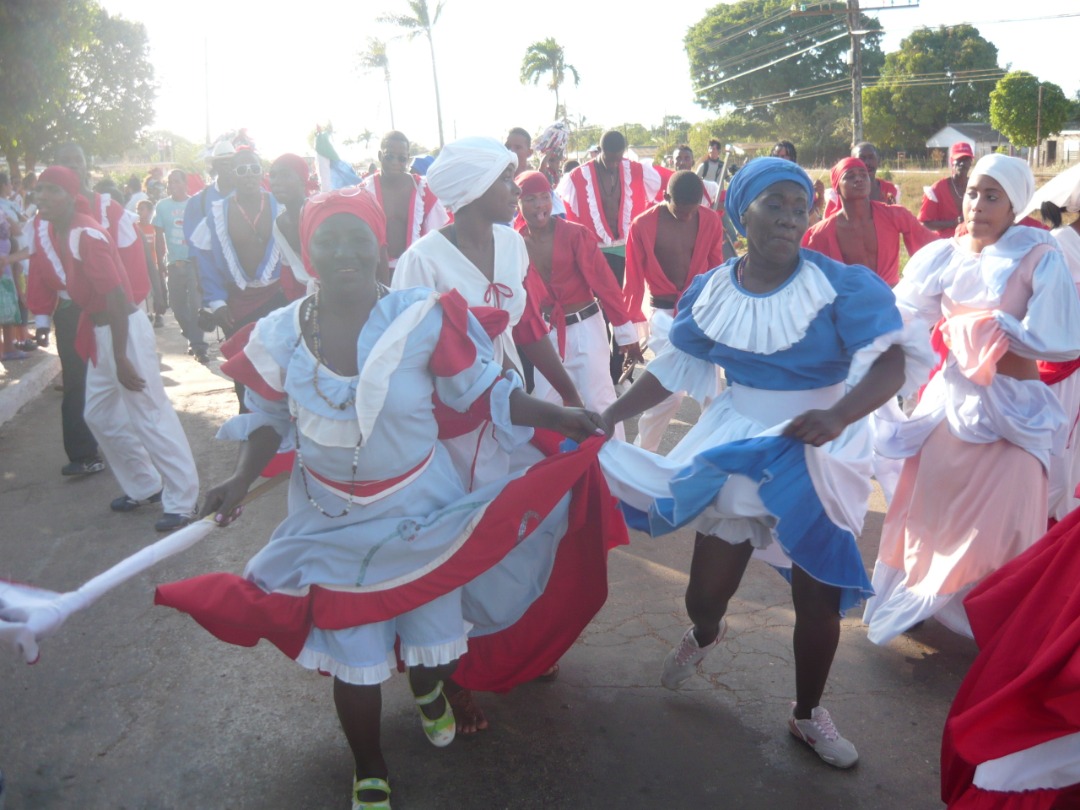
xmin=361 ymin=130 xmax=450 ymax=284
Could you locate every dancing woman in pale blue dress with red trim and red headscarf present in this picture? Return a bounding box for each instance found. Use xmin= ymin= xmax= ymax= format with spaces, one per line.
xmin=157 ymin=189 xmax=603 ymax=810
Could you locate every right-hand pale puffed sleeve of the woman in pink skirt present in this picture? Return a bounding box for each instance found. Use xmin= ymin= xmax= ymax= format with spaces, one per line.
xmin=994 ymin=248 xmax=1080 ymax=363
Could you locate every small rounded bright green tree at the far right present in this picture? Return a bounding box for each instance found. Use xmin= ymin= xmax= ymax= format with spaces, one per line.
xmin=990 ymin=70 xmax=1070 ymax=146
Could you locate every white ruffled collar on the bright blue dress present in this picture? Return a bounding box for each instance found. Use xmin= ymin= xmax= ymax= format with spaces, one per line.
xmin=691 ymin=258 xmax=836 ymax=354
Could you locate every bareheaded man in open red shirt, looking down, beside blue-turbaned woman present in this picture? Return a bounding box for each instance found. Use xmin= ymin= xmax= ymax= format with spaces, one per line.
xmin=623 ymin=171 xmax=724 ymax=451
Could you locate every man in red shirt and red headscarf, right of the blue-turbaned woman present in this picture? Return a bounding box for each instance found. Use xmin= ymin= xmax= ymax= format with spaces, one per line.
xmin=802 ymin=158 xmax=937 ymax=286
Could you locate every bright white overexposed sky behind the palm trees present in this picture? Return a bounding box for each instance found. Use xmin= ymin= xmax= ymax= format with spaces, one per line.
xmin=100 ymin=0 xmax=1080 ymax=161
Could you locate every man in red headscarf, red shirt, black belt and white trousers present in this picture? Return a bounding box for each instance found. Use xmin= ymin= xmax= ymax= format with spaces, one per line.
xmin=515 ymin=172 xmax=643 ymax=438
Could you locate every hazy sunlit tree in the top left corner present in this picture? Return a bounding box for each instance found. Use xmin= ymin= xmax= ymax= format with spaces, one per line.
xmin=0 ymin=0 xmax=156 ymax=172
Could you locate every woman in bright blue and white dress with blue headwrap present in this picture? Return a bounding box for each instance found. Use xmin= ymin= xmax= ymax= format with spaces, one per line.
xmin=600 ymin=158 xmax=929 ymax=768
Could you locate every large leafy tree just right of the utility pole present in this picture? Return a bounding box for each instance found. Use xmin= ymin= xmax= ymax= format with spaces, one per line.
xmin=863 ymin=25 xmax=1000 ymax=152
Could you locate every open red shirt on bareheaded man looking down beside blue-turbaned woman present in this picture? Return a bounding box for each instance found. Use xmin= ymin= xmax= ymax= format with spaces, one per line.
xmin=623 ymin=205 xmax=724 ymax=323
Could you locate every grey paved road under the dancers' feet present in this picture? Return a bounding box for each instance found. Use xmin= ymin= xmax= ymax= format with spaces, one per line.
xmin=0 ymin=319 xmax=975 ymax=810
